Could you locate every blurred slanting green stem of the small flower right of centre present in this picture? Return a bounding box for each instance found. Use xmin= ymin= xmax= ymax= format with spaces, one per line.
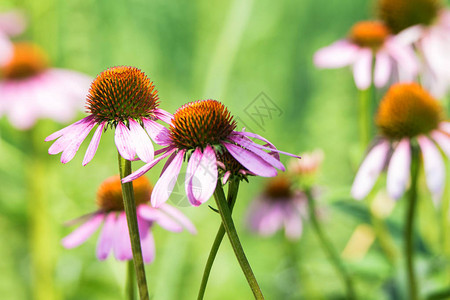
xmin=306 ymin=190 xmax=356 ymax=300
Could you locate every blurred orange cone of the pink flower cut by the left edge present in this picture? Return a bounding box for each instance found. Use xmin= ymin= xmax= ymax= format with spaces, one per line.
xmin=1 ymin=42 xmax=48 ymax=80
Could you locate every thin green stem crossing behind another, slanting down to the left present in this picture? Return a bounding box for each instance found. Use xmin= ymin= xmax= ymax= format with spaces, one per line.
xmin=197 ymin=180 xmax=240 ymax=300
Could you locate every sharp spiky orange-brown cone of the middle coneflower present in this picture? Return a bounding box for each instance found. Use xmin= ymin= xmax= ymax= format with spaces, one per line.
xmin=170 ymin=100 xmax=236 ymax=149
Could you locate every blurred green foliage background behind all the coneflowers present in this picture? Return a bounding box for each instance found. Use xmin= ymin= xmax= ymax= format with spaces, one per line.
xmin=0 ymin=0 xmax=450 ymax=300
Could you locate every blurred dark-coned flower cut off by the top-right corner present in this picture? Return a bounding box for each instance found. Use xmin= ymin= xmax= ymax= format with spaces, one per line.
xmin=379 ymin=0 xmax=450 ymax=97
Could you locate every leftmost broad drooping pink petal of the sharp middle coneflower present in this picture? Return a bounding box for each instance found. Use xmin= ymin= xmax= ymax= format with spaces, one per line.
xmin=151 ymin=150 xmax=185 ymax=207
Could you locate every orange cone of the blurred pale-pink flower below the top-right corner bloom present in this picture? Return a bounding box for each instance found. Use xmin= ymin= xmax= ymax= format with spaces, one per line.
xmin=349 ymin=21 xmax=390 ymax=50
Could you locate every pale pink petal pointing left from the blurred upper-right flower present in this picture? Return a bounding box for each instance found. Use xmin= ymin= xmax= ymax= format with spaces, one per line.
xmin=314 ymin=40 xmax=359 ymax=68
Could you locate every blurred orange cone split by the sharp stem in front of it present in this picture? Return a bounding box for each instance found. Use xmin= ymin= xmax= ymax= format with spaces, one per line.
xmin=97 ymin=175 xmax=152 ymax=211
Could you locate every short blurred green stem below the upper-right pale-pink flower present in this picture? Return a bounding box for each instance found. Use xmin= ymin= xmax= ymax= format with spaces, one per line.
xmin=359 ymin=87 xmax=373 ymax=151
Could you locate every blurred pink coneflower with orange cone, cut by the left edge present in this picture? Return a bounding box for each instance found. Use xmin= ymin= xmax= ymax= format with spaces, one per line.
xmin=0 ymin=42 xmax=91 ymax=130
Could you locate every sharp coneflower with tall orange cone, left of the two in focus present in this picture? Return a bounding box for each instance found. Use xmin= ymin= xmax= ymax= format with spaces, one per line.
xmin=45 ymin=66 xmax=173 ymax=166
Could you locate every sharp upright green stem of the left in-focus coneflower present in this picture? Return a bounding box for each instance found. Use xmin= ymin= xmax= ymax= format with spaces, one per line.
xmin=119 ymin=154 xmax=149 ymax=300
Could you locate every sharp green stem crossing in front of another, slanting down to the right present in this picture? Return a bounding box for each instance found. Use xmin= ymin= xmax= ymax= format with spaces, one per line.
xmin=214 ymin=180 xmax=264 ymax=300
